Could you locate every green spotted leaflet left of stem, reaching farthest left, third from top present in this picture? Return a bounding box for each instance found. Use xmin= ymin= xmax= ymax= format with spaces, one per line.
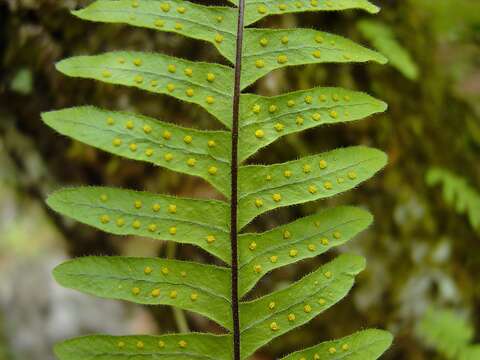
xmin=42 ymin=106 xmax=230 ymax=196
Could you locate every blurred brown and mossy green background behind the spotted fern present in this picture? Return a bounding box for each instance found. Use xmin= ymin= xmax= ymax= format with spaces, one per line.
xmin=0 ymin=0 xmax=480 ymax=360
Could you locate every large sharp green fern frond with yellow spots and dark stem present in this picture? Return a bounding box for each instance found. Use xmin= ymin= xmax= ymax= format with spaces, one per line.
xmin=43 ymin=0 xmax=391 ymax=360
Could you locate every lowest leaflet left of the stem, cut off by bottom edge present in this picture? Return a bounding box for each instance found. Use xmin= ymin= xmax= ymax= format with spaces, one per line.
xmin=55 ymin=333 xmax=232 ymax=360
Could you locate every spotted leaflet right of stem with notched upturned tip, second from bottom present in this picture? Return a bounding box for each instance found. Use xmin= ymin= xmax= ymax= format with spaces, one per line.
xmin=240 ymin=254 xmax=365 ymax=358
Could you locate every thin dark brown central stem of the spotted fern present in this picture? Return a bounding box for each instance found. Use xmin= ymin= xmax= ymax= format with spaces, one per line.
xmin=230 ymin=0 xmax=245 ymax=360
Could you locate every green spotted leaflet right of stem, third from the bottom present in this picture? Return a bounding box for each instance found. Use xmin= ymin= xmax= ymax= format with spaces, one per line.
xmin=238 ymin=206 xmax=373 ymax=295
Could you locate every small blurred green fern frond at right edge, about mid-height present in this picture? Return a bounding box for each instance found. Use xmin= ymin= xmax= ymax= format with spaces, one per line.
xmin=426 ymin=168 xmax=480 ymax=232
